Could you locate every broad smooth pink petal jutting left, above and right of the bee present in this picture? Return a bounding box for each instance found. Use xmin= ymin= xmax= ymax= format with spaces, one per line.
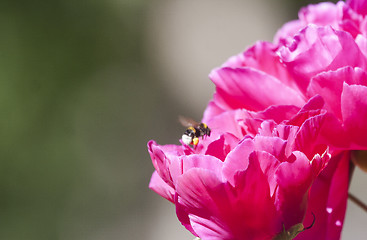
xmin=210 ymin=68 xmax=304 ymax=111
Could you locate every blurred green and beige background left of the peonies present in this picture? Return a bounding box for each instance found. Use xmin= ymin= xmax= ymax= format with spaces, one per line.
xmin=4 ymin=0 xmax=366 ymax=240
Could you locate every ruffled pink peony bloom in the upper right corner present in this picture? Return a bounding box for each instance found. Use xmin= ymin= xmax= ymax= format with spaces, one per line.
xmin=275 ymin=0 xmax=367 ymax=150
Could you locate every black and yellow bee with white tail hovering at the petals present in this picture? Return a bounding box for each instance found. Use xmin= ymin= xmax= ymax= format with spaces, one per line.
xmin=178 ymin=116 xmax=211 ymax=146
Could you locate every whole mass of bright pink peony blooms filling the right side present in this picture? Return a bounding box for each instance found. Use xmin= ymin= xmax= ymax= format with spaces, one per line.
xmin=148 ymin=0 xmax=367 ymax=240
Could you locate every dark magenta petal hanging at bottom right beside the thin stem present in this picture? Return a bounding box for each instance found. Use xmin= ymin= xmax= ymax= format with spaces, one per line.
xmin=297 ymin=152 xmax=349 ymax=240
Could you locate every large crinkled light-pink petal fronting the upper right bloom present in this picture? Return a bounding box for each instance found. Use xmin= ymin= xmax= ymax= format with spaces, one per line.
xmin=280 ymin=25 xmax=366 ymax=91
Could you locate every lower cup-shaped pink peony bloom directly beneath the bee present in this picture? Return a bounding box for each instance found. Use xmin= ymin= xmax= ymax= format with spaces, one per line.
xmin=148 ymin=102 xmax=332 ymax=240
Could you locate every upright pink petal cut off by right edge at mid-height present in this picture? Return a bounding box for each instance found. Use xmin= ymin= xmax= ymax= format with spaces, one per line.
xmin=341 ymin=83 xmax=367 ymax=149
